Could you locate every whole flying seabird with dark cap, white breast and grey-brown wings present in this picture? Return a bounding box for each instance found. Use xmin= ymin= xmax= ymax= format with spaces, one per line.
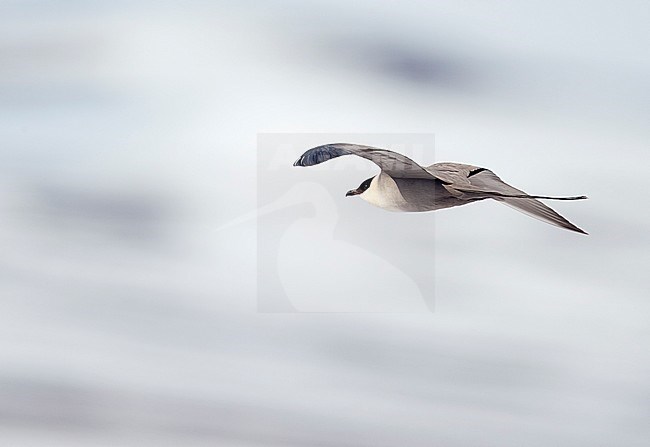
xmin=294 ymin=143 xmax=586 ymax=234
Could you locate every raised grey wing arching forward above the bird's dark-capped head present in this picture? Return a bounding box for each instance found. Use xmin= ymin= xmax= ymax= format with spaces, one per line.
xmin=293 ymin=143 xmax=436 ymax=180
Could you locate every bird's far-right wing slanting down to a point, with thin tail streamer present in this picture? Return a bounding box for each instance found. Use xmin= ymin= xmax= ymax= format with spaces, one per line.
xmin=468 ymin=169 xmax=587 ymax=234
